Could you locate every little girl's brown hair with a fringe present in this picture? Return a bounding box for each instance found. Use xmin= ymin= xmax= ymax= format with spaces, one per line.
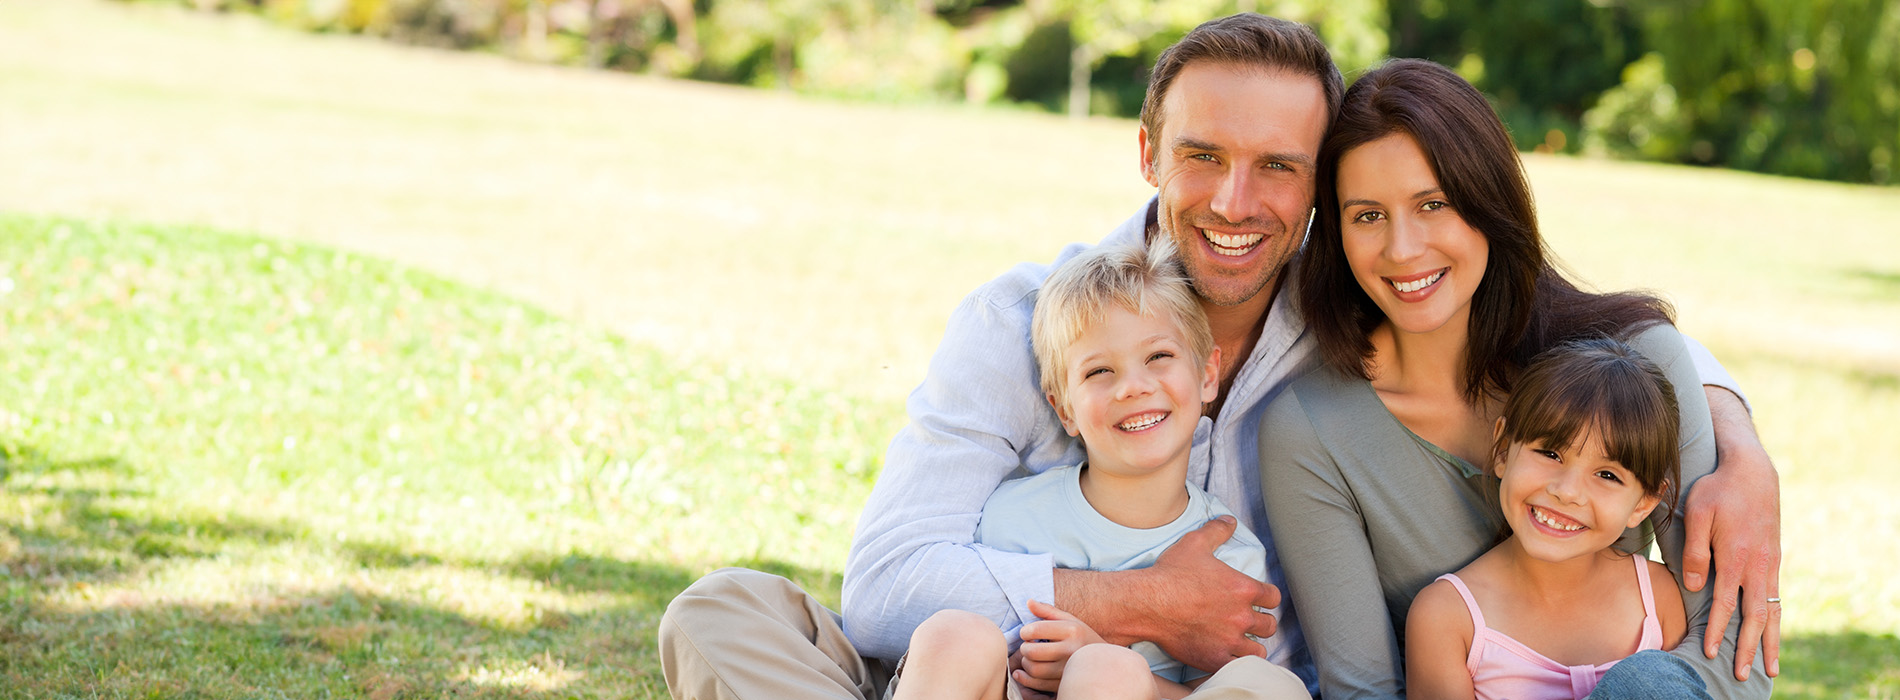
xmin=1492 ymin=339 xmax=1682 ymax=523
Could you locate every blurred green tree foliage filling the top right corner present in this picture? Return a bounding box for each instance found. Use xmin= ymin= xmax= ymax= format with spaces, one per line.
xmin=1590 ymin=0 xmax=1900 ymax=183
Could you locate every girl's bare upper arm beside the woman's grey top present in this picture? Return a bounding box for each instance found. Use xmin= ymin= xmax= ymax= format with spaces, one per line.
xmin=1406 ymin=580 xmax=1476 ymax=700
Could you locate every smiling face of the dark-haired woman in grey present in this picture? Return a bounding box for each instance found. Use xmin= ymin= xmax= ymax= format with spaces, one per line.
xmin=1338 ymin=131 xmax=1492 ymax=335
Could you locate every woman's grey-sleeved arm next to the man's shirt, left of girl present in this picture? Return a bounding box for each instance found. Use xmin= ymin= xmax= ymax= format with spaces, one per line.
xmin=1260 ymin=388 xmax=1404 ymax=698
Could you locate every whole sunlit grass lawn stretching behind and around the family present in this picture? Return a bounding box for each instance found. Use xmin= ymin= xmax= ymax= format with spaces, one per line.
xmin=0 ymin=2 xmax=1900 ymax=698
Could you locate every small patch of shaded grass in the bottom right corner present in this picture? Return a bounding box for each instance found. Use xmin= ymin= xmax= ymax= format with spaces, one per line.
xmin=1775 ymin=630 xmax=1900 ymax=698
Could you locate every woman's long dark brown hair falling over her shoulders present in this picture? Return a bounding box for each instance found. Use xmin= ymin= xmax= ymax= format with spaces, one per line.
xmin=1298 ymin=59 xmax=1674 ymax=403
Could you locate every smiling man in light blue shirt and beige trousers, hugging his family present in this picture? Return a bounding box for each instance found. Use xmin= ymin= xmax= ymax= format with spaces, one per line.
xmin=659 ymin=13 xmax=1780 ymax=698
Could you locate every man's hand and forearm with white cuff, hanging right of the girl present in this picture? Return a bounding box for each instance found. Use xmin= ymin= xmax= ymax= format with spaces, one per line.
xmin=1682 ymin=386 xmax=1780 ymax=681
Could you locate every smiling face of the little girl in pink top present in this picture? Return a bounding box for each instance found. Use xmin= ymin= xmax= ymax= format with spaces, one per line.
xmin=1497 ymin=426 xmax=1659 ymax=561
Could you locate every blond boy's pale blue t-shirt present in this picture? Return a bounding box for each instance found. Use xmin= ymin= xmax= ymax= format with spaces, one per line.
xmin=977 ymin=466 xmax=1267 ymax=683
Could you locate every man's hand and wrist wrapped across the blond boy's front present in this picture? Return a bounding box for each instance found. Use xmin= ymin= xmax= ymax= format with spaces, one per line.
xmin=1056 ymin=515 xmax=1281 ymax=671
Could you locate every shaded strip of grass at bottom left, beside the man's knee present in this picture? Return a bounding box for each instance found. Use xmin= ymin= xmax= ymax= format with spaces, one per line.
xmin=0 ymin=439 xmax=838 ymax=700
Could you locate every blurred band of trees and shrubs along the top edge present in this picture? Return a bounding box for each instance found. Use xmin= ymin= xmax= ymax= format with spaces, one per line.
xmin=152 ymin=0 xmax=1900 ymax=183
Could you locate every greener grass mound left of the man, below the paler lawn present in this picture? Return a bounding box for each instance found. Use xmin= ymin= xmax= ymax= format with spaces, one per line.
xmin=0 ymin=217 xmax=897 ymax=696
